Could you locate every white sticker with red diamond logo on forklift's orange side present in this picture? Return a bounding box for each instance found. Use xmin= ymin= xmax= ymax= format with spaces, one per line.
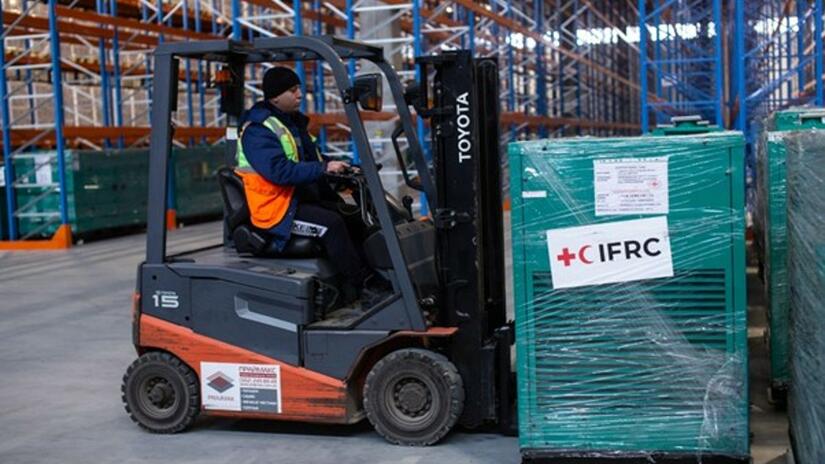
xmin=201 ymin=362 xmax=281 ymax=414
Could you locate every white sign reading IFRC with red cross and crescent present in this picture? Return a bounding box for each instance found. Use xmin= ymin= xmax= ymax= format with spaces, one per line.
xmin=547 ymin=216 xmax=673 ymax=288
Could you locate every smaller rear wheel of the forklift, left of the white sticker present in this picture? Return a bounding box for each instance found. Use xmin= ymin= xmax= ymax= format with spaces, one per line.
xmin=121 ymin=352 xmax=201 ymax=433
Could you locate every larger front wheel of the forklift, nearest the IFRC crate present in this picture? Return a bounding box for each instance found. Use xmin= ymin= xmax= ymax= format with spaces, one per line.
xmin=364 ymin=348 xmax=464 ymax=446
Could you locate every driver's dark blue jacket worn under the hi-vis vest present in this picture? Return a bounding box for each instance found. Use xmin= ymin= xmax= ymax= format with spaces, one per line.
xmin=241 ymin=101 xmax=326 ymax=250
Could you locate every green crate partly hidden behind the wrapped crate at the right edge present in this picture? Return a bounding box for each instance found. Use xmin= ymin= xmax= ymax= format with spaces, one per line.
xmin=753 ymin=108 xmax=825 ymax=401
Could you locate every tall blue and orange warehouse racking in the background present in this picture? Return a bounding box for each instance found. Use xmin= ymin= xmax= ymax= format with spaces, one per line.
xmin=0 ymin=0 xmax=823 ymax=247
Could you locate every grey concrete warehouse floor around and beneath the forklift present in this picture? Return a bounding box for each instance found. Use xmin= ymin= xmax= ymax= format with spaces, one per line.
xmin=0 ymin=223 xmax=788 ymax=464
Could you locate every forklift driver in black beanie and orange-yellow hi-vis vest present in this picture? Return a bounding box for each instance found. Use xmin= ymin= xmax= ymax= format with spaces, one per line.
xmin=236 ymin=67 xmax=370 ymax=299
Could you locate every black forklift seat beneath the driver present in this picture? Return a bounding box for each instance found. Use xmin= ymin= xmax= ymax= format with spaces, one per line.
xmin=218 ymin=167 xmax=324 ymax=259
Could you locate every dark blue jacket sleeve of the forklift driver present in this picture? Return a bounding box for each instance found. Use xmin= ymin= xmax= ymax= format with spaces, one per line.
xmin=241 ymin=123 xmax=324 ymax=185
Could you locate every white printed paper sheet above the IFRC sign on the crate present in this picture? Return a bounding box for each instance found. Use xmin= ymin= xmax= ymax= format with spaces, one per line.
xmin=593 ymin=157 xmax=670 ymax=216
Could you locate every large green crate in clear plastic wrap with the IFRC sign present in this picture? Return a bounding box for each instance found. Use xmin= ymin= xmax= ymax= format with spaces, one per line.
xmin=509 ymin=132 xmax=749 ymax=462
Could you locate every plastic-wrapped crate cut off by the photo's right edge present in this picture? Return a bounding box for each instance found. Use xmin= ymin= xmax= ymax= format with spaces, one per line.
xmin=786 ymin=130 xmax=825 ymax=464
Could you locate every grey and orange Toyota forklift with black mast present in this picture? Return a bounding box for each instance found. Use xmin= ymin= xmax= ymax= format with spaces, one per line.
xmin=122 ymin=37 xmax=514 ymax=446
